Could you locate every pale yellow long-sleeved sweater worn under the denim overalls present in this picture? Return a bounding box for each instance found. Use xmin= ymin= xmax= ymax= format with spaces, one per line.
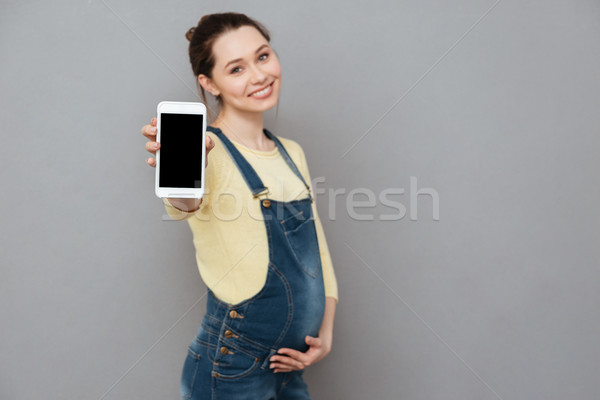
xmin=163 ymin=131 xmax=338 ymax=304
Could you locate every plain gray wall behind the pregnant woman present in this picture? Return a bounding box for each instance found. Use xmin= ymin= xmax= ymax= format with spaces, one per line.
xmin=0 ymin=0 xmax=600 ymax=400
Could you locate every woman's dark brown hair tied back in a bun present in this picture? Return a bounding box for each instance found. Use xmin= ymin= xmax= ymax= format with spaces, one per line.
xmin=185 ymin=12 xmax=271 ymax=117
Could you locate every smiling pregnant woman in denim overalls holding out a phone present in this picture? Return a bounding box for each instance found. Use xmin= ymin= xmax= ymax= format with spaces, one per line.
xmin=142 ymin=13 xmax=338 ymax=400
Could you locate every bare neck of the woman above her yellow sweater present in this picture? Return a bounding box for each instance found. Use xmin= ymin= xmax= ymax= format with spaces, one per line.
xmin=211 ymin=105 xmax=274 ymax=151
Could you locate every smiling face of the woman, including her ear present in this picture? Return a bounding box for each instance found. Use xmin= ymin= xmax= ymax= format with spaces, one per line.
xmin=198 ymin=26 xmax=281 ymax=112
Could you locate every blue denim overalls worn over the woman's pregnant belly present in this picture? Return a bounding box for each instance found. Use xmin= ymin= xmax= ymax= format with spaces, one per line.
xmin=180 ymin=126 xmax=325 ymax=400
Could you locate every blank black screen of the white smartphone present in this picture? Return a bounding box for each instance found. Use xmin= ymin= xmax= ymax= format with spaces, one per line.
xmin=158 ymin=113 xmax=204 ymax=188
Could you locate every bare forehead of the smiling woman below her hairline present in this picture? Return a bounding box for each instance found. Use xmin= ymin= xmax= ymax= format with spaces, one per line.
xmin=213 ymin=26 xmax=269 ymax=65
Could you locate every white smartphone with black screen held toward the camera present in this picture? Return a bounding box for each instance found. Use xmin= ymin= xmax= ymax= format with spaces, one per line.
xmin=155 ymin=101 xmax=206 ymax=199
